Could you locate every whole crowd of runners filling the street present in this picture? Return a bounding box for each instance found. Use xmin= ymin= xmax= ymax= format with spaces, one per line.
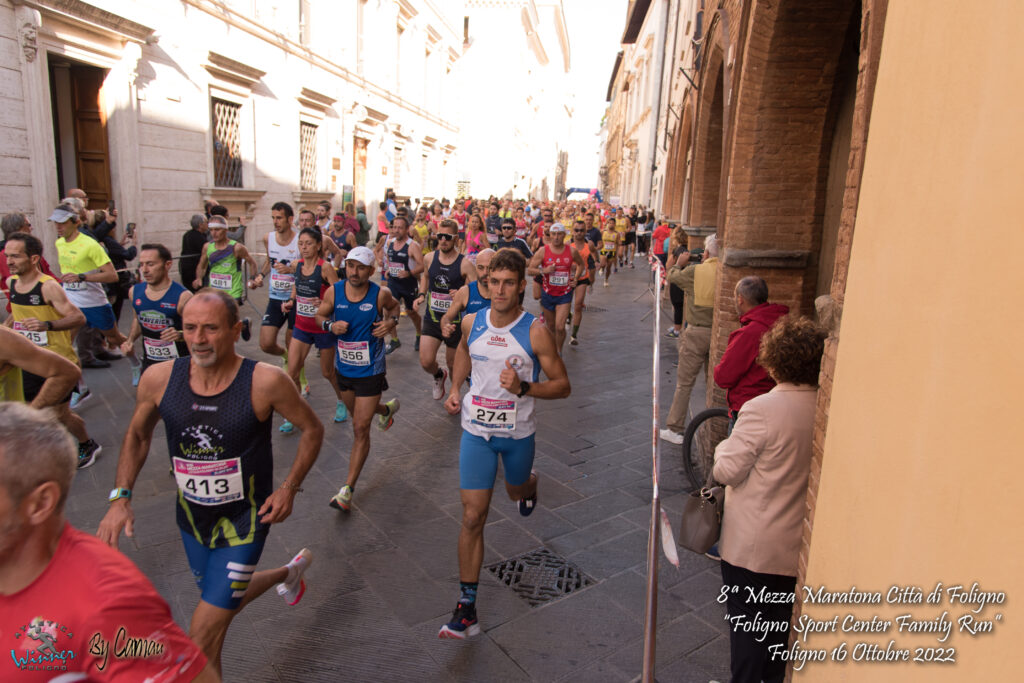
xmin=0 ymin=190 xmax=653 ymax=680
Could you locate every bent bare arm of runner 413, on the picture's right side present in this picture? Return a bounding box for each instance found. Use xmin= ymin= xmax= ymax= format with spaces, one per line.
xmin=252 ymin=362 xmax=324 ymax=524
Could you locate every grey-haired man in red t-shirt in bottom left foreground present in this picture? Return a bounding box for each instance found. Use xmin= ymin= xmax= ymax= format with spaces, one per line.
xmin=0 ymin=402 xmax=219 ymax=683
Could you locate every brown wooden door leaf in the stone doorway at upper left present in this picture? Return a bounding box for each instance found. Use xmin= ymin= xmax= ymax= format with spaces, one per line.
xmin=71 ymin=65 xmax=113 ymax=209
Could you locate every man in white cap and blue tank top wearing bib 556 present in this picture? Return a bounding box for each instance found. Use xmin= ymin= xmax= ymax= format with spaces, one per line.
xmin=316 ymin=247 xmax=399 ymax=512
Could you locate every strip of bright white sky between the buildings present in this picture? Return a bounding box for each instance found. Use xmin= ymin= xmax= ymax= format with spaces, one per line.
xmin=562 ymin=0 xmax=629 ymax=187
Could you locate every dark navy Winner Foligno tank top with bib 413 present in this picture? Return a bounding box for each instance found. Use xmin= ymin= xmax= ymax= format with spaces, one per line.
xmin=160 ymin=357 xmax=273 ymax=548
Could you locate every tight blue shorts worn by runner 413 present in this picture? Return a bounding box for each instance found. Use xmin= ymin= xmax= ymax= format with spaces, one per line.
xmin=180 ymin=529 xmax=266 ymax=609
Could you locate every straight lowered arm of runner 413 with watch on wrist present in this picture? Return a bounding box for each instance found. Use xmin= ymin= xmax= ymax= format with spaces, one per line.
xmin=96 ymin=362 xmax=174 ymax=548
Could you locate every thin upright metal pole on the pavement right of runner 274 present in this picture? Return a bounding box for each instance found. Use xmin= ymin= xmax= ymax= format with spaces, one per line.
xmin=640 ymin=256 xmax=664 ymax=683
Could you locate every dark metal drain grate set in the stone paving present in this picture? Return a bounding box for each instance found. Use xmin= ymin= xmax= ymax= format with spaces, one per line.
xmin=487 ymin=548 xmax=594 ymax=607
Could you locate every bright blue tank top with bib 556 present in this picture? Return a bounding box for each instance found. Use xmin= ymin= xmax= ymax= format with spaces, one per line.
xmin=334 ymin=282 xmax=387 ymax=377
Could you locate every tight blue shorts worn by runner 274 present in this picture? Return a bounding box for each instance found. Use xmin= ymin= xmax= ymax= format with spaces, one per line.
xmin=459 ymin=429 xmax=537 ymax=489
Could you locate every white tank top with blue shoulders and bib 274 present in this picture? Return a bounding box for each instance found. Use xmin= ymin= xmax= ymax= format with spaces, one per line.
xmin=462 ymin=308 xmax=541 ymax=438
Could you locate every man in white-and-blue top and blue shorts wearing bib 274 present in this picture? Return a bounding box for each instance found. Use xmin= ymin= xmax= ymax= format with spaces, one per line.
xmin=437 ymin=249 xmax=570 ymax=639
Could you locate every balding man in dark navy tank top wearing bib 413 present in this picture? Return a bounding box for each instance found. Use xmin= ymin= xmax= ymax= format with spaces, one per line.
xmin=97 ymin=290 xmax=324 ymax=674
